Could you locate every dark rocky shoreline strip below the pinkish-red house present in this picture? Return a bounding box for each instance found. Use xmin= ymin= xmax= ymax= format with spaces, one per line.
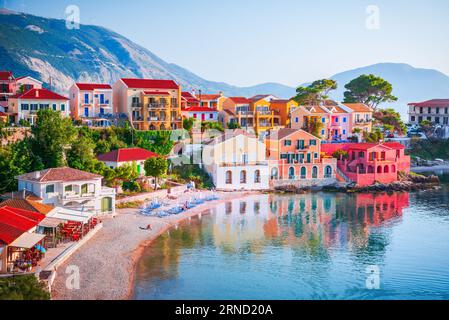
xmin=274 ymin=174 xmax=440 ymax=194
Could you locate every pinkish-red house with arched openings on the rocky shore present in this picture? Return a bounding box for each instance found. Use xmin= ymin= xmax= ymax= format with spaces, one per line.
xmin=321 ymin=142 xmax=410 ymax=186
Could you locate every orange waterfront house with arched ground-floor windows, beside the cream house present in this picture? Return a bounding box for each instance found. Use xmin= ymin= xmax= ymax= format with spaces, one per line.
xmin=265 ymin=128 xmax=336 ymax=184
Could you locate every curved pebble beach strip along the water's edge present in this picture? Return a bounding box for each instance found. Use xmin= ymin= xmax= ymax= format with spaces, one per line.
xmin=52 ymin=192 xmax=249 ymax=300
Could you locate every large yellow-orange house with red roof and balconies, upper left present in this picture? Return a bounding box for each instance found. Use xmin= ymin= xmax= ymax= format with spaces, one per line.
xmin=113 ymin=78 xmax=182 ymax=130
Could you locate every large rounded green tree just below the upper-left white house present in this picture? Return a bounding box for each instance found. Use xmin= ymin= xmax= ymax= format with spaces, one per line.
xmin=31 ymin=109 xmax=76 ymax=168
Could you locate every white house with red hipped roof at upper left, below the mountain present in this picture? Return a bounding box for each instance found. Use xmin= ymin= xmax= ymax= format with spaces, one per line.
xmin=7 ymin=89 xmax=70 ymax=124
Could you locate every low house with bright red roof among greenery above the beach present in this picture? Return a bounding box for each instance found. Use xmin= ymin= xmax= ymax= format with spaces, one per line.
xmin=97 ymin=148 xmax=159 ymax=176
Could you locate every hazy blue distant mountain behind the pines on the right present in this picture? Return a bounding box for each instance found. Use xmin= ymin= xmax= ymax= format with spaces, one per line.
xmin=331 ymin=63 xmax=449 ymax=118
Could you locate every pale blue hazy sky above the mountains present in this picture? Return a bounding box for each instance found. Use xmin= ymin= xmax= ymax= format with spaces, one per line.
xmin=0 ymin=0 xmax=449 ymax=86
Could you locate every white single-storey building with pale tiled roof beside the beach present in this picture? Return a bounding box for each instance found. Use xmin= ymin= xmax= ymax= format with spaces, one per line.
xmin=16 ymin=167 xmax=115 ymax=214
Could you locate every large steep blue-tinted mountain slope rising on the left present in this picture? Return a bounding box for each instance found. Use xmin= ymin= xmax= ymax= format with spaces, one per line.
xmin=0 ymin=9 xmax=295 ymax=98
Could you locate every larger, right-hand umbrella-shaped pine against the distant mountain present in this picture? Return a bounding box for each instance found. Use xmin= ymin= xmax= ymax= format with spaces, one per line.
xmin=344 ymin=74 xmax=398 ymax=110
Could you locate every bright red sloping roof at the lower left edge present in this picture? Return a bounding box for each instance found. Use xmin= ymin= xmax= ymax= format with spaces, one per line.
xmin=0 ymin=206 xmax=45 ymax=244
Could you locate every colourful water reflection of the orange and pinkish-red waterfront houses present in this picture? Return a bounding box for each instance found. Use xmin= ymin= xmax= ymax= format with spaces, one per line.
xmin=265 ymin=193 xmax=409 ymax=248
